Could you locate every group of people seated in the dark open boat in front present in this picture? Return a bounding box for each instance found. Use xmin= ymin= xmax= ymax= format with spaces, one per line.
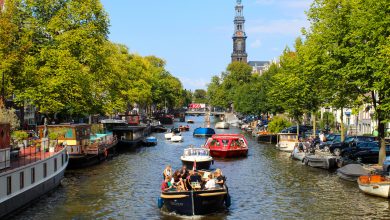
xmin=161 ymin=165 xmax=226 ymax=192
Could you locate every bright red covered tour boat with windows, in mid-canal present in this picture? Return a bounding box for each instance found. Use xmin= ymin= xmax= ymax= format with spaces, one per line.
xmin=204 ymin=134 xmax=248 ymax=158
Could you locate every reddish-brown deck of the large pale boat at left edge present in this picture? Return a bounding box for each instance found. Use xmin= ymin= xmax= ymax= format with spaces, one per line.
xmin=0 ymin=147 xmax=62 ymax=173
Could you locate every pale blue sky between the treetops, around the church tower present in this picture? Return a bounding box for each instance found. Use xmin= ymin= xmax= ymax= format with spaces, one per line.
xmin=101 ymin=0 xmax=312 ymax=91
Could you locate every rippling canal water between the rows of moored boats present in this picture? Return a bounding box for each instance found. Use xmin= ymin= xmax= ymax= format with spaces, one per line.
xmin=14 ymin=117 xmax=390 ymax=219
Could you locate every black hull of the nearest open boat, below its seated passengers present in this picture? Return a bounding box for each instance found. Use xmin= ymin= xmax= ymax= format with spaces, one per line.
xmin=158 ymin=171 xmax=231 ymax=216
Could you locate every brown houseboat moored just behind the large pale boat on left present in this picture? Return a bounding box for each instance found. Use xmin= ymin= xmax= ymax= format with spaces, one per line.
xmin=38 ymin=124 xmax=117 ymax=168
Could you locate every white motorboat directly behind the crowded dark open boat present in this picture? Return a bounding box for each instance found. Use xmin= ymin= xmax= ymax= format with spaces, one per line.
xmin=180 ymin=147 xmax=213 ymax=170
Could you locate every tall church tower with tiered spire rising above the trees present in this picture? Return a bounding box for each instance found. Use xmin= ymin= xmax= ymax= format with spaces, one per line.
xmin=232 ymin=0 xmax=248 ymax=63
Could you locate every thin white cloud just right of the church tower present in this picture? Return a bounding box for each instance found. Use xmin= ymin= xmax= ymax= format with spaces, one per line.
xmin=247 ymin=19 xmax=309 ymax=36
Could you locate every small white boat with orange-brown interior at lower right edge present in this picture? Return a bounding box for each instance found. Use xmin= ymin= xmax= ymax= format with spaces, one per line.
xmin=357 ymin=175 xmax=390 ymax=198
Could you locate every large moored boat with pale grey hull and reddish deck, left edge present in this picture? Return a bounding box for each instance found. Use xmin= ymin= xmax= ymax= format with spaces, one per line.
xmin=0 ymin=123 xmax=69 ymax=219
